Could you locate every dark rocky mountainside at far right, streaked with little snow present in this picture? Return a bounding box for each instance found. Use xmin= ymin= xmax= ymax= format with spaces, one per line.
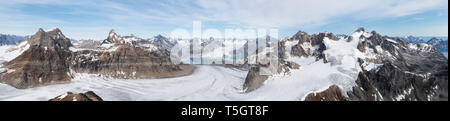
xmin=304 ymin=30 xmax=448 ymax=101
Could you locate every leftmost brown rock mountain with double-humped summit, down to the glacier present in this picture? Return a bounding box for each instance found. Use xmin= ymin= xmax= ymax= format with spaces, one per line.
xmin=0 ymin=29 xmax=71 ymax=89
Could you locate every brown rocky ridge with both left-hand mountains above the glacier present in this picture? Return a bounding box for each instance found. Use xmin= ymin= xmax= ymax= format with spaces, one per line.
xmin=0 ymin=28 xmax=195 ymax=89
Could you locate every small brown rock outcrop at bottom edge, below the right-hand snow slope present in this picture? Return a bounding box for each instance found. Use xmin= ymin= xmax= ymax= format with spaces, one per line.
xmin=305 ymin=85 xmax=348 ymax=101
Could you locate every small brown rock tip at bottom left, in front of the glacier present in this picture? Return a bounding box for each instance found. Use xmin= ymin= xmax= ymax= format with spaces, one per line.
xmin=49 ymin=91 xmax=103 ymax=101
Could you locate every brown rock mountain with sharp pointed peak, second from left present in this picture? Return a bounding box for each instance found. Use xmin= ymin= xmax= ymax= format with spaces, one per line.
xmin=71 ymin=30 xmax=195 ymax=78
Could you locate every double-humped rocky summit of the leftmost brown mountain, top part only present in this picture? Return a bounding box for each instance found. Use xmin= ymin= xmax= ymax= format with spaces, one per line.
xmin=28 ymin=28 xmax=72 ymax=49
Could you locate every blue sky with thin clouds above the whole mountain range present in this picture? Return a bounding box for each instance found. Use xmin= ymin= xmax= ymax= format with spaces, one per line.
xmin=0 ymin=0 xmax=448 ymax=40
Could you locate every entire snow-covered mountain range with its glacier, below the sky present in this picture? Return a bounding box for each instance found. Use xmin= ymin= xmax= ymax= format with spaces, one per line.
xmin=0 ymin=28 xmax=448 ymax=101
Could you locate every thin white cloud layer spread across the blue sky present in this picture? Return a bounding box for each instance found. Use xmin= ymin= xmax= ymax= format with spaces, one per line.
xmin=0 ymin=0 xmax=448 ymax=38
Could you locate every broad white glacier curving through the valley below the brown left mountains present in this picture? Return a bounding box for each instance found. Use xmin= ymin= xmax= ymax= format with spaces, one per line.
xmin=0 ymin=66 xmax=246 ymax=101
